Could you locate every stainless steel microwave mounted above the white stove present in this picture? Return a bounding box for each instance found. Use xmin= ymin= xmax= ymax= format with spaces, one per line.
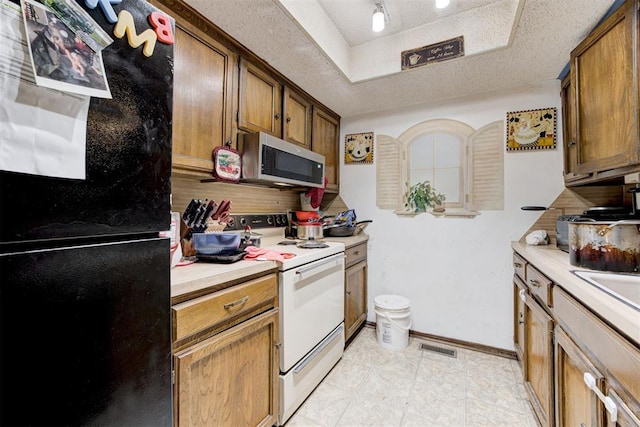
xmin=239 ymin=132 xmax=325 ymax=188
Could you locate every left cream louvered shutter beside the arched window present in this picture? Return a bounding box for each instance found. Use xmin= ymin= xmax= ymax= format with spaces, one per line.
xmin=375 ymin=135 xmax=403 ymax=210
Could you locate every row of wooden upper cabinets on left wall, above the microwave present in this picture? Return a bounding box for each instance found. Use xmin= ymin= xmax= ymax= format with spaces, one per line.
xmin=150 ymin=0 xmax=340 ymax=186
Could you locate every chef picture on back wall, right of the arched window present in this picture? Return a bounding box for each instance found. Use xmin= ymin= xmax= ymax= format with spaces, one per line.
xmin=507 ymin=107 xmax=556 ymax=151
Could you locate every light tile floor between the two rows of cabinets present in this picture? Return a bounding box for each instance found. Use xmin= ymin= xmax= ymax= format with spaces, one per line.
xmin=285 ymin=327 xmax=538 ymax=427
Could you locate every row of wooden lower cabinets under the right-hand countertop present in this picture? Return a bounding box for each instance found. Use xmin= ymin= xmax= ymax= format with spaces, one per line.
xmin=513 ymin=253 xmax=640 ymax=427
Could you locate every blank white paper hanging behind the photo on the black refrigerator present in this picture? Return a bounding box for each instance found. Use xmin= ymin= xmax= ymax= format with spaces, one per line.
xmin=0 ymin=0 xmax=90 ymax=179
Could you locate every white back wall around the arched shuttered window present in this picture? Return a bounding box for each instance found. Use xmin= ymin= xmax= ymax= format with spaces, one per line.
xmin=340 ymin=80 xmax=564 ymax=349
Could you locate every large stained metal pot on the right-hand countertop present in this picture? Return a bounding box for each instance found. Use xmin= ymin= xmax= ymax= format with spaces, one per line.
xmin=569 ymin=220 xmax=640 ymax=273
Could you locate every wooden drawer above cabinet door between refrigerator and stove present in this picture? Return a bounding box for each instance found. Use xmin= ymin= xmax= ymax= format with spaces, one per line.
xmin=171 ymin=274 xmax=278 ymax=341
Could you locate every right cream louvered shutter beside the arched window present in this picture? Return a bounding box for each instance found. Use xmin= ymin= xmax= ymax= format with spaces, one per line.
xmin=469 ymin=120 xmax=504 ymax=210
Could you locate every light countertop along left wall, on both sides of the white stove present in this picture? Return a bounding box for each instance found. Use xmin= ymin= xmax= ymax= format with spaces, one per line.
xmin=171 ymin=233 xmax=369 ymax=304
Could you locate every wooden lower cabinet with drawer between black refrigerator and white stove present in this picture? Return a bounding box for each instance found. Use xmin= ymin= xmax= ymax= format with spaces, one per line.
xmin=172 ymin=274 xmax=280 ymax=427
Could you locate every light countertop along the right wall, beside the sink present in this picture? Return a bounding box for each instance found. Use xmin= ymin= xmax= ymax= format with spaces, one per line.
xmin=511 ymin=242 xmax=640 ymax=345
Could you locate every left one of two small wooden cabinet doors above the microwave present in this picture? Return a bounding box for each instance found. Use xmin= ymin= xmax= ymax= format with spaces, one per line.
xmin=238 ymin=59 xmax=282 ymax=138
